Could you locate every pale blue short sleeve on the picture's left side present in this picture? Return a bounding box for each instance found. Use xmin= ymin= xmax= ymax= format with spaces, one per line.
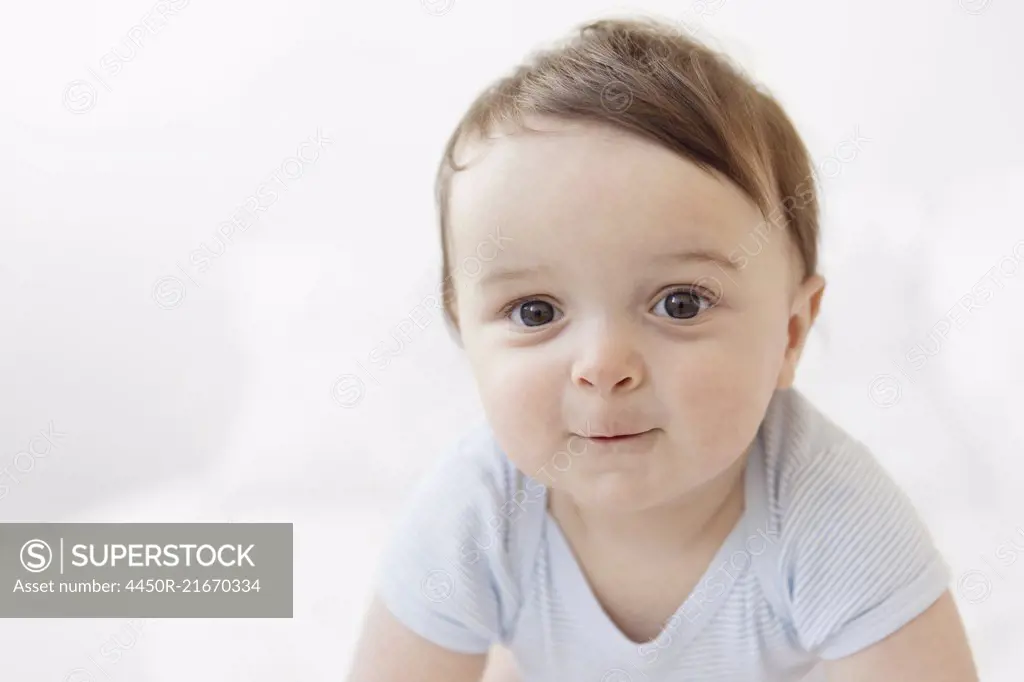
xmin=376 ymin=430 xmax=515 ymax=653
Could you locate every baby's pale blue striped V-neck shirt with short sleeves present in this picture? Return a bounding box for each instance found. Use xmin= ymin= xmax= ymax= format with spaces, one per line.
xmin=376 ymin=388 xmax=951 ymax=682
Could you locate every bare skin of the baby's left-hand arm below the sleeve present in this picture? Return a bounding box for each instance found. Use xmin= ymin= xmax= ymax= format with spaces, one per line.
xmin=347 ymin=599 xmax=487 ymax=682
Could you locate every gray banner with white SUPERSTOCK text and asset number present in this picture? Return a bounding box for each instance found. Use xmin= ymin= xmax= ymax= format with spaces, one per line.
xmin=0 ymin=523 xmax=293 ymax=619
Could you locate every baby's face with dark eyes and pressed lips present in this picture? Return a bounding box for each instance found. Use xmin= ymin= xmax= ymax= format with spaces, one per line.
xmin=450 ymin=122 xmax=815 ymax=509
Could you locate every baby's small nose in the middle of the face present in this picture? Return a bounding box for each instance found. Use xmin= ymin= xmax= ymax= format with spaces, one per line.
xmin=572 ymin=329 xmax=645 ymax=396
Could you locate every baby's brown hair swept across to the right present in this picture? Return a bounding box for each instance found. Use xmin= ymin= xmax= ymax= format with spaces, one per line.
xmin=435 ymin=17 xmax=818 ymax=331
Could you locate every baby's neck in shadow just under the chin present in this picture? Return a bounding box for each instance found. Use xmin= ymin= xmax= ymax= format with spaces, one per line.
xmin=550 ymin=450 xmax=750 ymax=556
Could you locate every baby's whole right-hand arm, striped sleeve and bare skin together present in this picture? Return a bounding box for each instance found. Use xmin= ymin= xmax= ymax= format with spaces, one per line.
xmin=778 ymin=441 xmax=978 ymax=682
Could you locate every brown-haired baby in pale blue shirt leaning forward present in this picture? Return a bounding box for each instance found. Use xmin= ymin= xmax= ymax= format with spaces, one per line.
xmin=349 ymin=18 xmax=976 ymax=682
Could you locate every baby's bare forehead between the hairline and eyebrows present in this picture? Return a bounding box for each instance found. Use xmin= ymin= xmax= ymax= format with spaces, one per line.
xmin=449 ymin=123 xmax=778 ymax=268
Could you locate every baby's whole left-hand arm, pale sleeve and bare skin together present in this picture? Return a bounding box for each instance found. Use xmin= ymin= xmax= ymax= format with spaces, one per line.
xmin=348 ymin=430 xmax=518 ymax=682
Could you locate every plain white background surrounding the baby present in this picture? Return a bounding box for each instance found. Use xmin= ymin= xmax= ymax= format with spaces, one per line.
xmin=0 ymin=0 xmax=1024 ymax=682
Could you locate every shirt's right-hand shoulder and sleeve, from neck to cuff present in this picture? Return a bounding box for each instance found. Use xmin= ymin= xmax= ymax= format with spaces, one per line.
xmin=761 ymin=389 xmax=950 ymax=658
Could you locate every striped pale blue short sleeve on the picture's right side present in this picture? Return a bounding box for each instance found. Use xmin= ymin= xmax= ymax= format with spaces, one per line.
xmin=781 ymin=439 xmax=951 ymax=659
